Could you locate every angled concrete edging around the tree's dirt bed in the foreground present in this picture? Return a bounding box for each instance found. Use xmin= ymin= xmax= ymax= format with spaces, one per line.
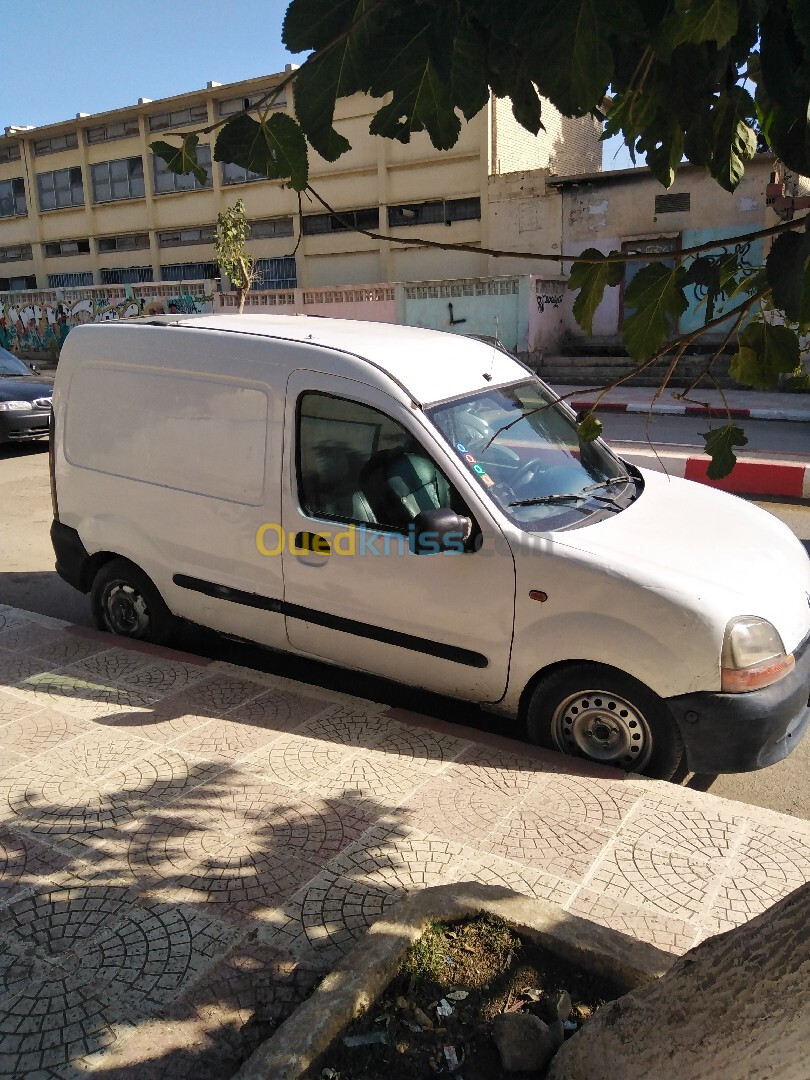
xmin=232 ymin=881 xmax=677 ymax=1080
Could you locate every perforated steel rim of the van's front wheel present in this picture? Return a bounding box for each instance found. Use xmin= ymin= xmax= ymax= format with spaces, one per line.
xmin=551 ymin=690 xmax=652 ymax=772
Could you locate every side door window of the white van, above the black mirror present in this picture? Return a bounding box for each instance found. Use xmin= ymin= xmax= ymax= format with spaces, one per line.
xmin=297 ymin=391 xmax=469 ymax=529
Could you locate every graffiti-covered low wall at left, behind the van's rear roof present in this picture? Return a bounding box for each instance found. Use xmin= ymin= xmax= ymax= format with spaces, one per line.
xmin=0 ymin=291 xmax=213 ymax=354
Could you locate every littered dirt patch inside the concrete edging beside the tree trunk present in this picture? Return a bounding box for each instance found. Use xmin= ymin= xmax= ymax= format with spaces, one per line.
xmin=307 ymin=915 xmax=623 ymax=1080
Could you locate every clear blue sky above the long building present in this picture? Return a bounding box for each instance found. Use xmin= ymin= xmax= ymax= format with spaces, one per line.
xmin=0 ymin=0 xmax=631 ymax=168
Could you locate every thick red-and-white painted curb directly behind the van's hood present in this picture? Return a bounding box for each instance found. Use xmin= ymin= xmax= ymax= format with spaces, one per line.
xmin=610 ymin=442 xmax=810 ymax=499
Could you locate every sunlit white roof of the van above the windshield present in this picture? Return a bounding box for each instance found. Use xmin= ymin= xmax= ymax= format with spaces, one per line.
xmin=144 ymin=314 xmax=534 ymax=404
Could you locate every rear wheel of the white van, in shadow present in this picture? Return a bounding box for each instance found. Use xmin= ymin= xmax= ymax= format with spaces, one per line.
xmin=90 ymin=558 xmax=176 ymax=645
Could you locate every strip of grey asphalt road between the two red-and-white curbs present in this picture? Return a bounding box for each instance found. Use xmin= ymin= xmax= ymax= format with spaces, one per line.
xmin=598 ymin=413 xmax=810 ymax=457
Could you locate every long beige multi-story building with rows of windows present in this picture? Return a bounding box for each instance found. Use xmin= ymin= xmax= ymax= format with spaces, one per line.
xmin=0 ymin=73 xmax=600 ymax=292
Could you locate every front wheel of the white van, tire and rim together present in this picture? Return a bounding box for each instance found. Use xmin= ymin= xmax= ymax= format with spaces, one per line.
xmin=526 ymin=663 xmax=684 ymax=780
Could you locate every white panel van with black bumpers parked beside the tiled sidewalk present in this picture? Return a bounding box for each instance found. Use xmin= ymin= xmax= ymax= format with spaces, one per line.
xmin=52 ymin=315 xmax=810 ymax=777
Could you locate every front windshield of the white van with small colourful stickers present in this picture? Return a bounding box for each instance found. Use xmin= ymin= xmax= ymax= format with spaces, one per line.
xmin=426 ymin=379 xmax=636 ymax=531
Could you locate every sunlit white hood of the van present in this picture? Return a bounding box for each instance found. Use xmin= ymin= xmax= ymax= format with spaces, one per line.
xmin=554 ymin=470 xmax=810 ymax=652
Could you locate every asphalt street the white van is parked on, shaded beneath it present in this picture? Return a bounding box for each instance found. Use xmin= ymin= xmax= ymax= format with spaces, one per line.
xmin=0 ymin=438 xmax=810 ymax=819
